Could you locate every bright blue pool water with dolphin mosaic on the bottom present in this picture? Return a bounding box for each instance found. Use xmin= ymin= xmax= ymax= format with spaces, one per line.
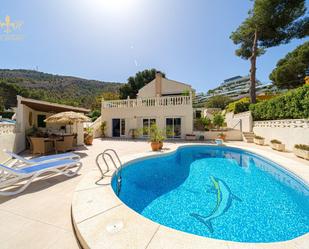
xmin=112 ymin=146 xmax=309 ymax=242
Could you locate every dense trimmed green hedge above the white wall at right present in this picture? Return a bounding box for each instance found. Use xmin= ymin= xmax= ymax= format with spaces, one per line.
xmin=249 ymin=85 xmax=309 ymax=120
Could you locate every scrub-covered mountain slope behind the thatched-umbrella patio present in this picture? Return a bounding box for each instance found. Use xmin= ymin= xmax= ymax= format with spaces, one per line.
xmin=0 ymin=69 xmax=121 ymax=109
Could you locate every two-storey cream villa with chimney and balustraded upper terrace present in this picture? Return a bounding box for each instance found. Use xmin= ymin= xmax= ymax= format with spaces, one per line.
xmin=101 ymin=72 xmax=194 ymax=138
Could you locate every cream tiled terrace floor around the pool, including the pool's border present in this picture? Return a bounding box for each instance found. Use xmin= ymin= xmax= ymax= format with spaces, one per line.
xmin=0 ymin=139 xmax=309 ymax=249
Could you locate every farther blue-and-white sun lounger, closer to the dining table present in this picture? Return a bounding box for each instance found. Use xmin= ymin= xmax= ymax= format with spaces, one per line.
xmin=3 ymin=149 xmax=80 ymax=165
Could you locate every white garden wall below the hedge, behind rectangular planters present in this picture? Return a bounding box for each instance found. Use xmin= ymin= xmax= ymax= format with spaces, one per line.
xmin=253 ymin=119 xmax=309 ymax=151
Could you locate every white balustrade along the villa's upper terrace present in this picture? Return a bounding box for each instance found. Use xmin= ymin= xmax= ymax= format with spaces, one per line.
xmin=102 ymin=96 xmax=192 ymax=109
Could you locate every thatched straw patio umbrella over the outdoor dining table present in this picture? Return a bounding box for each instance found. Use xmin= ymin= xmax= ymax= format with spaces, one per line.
xmin=44 ymin=112 xmax=91 ymax=133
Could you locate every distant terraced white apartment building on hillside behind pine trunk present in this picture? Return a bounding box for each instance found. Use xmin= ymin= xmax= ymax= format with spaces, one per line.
xmin=194 ymin=76 xmax=275 ymax=104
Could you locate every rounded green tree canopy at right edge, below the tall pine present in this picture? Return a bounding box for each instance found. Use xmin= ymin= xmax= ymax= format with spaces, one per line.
xmin=269 ymin=42 xmax=309 ymax=89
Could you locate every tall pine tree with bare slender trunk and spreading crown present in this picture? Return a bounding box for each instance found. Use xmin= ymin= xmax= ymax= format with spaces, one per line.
xmin=230 ymin=0 xmax=309 ymax=103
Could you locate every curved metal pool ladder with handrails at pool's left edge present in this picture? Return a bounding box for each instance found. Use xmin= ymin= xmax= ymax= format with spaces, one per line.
xmin=96 ymin=149 xmax=122 ymax=196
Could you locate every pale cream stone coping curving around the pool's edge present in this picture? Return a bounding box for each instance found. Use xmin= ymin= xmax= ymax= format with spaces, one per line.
xmin=71 ymin=143 xmax=309 ymax=249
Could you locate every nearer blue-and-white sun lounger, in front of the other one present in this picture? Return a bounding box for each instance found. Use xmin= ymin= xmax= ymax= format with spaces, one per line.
xmin=0 ymin=159 xmax=82 ymax=196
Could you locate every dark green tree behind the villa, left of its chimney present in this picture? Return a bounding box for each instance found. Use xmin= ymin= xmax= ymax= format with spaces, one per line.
xmin=119 ymin=68 xmax=165 ymax=99
